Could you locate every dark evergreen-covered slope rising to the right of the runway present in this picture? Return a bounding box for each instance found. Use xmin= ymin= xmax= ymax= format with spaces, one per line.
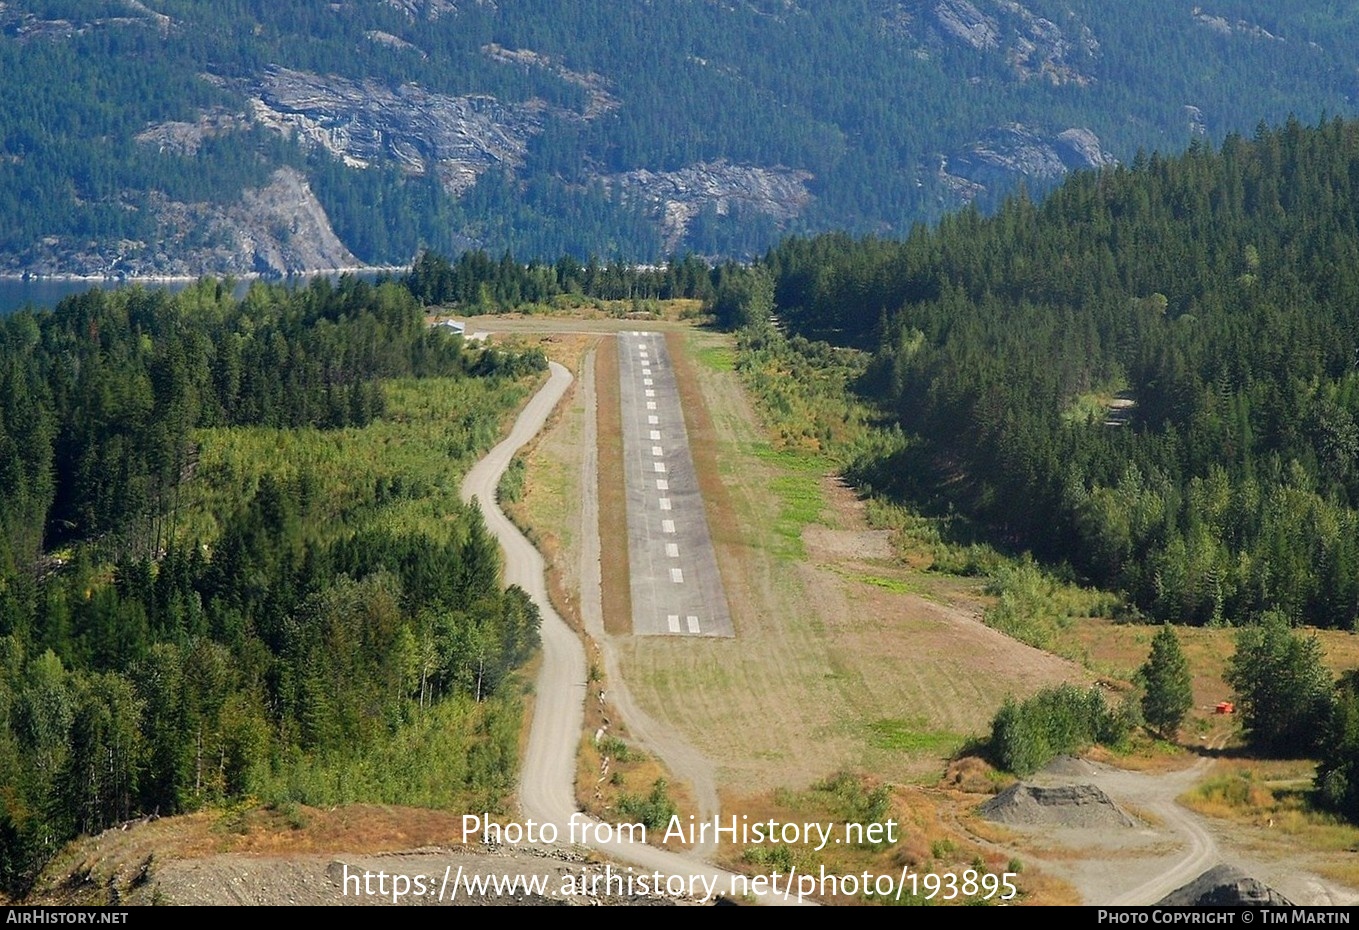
xmin=766 ymin=120 xmax=1359 ymax=628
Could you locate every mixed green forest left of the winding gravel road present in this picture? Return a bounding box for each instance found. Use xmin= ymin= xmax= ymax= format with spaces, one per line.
xmin=0 ymin=279 xmax=545 ymax=889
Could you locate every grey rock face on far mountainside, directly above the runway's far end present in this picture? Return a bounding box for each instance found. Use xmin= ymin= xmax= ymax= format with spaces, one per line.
xmin=602 ymin=160 xmax=811 ymax=252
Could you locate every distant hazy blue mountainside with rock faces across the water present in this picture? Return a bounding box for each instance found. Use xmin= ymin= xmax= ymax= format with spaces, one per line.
xmin=0 ymin=0 xmax=1359 ymax=275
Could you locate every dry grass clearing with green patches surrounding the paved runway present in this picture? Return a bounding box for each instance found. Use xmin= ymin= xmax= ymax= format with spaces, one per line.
xmin=530 ymin=326 xmax=1089 ymax=797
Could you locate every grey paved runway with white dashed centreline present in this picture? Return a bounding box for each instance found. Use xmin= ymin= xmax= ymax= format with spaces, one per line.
xmin=618 ymin=332 xmax=735 ymax=636
